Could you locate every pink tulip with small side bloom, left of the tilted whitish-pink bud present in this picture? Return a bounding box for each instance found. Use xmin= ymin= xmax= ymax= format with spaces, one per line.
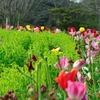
xmin=54 ymin=57 xmax=70 ymax=69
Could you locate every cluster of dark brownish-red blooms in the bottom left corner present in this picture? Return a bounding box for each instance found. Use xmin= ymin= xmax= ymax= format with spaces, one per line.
xmin=0 ymin=90 xmax=18 ymax=100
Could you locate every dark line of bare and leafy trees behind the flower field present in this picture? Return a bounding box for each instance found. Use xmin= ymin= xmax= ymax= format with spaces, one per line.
xmin=0 ymin=0 xmax=100 ymax=30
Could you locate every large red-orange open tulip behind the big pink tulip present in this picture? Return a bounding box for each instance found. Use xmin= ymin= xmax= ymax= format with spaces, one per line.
xmin=55 ymin=69 xmax=78 ymax=90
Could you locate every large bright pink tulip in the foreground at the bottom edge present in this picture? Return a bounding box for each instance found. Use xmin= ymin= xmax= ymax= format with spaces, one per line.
xmin=66 ymin=81 xmax=87 ymax=100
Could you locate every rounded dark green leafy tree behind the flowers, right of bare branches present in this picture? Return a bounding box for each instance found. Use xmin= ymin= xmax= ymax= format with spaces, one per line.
xmin=50 ymin=6 xmax=98 ymax=29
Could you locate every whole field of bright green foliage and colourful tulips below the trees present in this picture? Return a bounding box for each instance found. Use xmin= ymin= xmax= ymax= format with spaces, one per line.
xmin=0 ymin=24 xmax=100 ymax=100
